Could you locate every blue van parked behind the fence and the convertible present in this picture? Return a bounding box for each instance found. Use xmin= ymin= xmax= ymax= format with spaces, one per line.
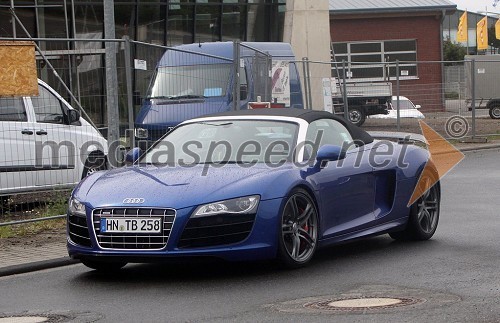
xmin=135 ymin=42 xmax=303 ymax=144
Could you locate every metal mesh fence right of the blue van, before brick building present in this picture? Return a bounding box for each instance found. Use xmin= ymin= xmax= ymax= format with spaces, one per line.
xmin=305 ymin=56 xmax=500 ymax=140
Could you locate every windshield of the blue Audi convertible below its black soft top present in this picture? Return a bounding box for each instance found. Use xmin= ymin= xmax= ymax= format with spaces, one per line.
xmin=139 ymin=120 xmax=299 ymax=165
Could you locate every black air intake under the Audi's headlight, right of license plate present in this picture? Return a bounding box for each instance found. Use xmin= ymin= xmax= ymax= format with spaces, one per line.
xmin=178 ymin=214 xmax=255 ymax=248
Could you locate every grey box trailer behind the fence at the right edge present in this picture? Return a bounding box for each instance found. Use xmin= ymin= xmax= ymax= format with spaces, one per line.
xmin=465 ymin=55 xmax=500 ymax=119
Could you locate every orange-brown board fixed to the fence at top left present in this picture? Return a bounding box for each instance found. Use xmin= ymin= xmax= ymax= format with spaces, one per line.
xmin=0 ymin=41 xmax=38 ymax=97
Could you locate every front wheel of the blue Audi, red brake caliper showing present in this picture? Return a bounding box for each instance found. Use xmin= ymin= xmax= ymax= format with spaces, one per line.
xmin=278 ymin=188 xmax=319 ymax=268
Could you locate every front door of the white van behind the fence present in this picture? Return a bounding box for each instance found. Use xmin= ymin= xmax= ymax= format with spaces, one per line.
xmin=30 ymin=84 xmax=80 ymax=187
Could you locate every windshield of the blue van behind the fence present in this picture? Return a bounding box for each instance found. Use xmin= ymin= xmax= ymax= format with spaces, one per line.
xmin=148 ymin=64 xmax=231 ymax=99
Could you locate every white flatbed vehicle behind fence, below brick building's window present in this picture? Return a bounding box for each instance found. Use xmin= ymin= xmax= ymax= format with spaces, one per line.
xmin=332 ymin=78 xmax=392 ymax=126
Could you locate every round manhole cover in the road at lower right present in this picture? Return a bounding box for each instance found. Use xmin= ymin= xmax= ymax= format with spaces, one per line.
xmin=304 ymin=297 xmax=423 ymax=311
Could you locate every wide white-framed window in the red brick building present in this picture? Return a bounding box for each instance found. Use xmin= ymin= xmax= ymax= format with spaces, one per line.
xmin=332 ymin=39 xmax=418 ymax=81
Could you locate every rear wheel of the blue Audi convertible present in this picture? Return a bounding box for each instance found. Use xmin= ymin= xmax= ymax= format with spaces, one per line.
xmin=389 ymin=178 xmax=441 ymax=241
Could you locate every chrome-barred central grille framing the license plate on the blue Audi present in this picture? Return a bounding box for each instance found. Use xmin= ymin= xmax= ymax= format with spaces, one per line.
xmin=92 ymin=208 xmax=175 ymax=250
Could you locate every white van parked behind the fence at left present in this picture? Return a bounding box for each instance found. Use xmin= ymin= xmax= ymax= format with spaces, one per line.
xmin=0 ymin=80 xmax=108 ymax=195
